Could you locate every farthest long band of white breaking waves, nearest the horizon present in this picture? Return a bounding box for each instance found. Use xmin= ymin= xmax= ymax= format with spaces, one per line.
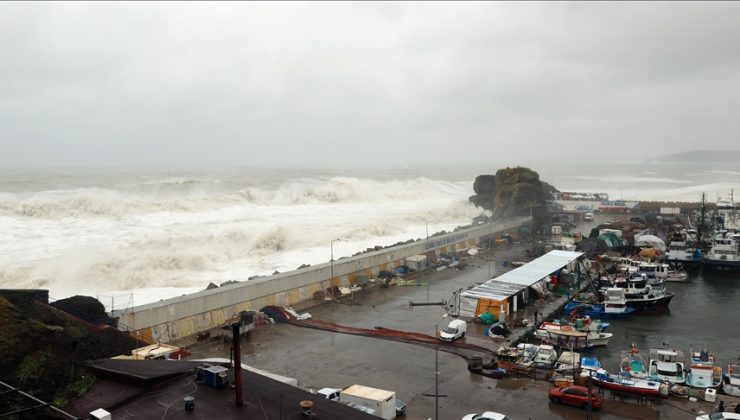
xmin=0 ymin=177 xmax=468 ymax=219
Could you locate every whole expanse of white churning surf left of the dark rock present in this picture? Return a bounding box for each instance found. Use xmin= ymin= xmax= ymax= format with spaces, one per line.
xmin=0 ymin=177 xmax=480 ymax=303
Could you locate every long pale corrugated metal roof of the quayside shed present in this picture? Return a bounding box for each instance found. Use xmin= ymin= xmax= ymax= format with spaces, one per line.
xmin=462 ymin=251 xmax=583 ymax=301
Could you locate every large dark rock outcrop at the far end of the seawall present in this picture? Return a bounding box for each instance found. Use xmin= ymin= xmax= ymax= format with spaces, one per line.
xmin=470 ymin=166 xmax=558 ymax=232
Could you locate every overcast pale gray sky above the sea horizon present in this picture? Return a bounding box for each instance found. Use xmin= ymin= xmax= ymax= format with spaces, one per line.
xmin=0 ymin=2 xmax=740 ymax=167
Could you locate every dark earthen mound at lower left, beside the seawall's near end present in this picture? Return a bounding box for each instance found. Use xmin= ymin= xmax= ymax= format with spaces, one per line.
xmin=0 ymin=296 xmax=139 ymax=406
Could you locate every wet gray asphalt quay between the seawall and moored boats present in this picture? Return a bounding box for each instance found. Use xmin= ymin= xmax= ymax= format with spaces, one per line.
xmin=185 ymin=244 xmax=724 ymax=420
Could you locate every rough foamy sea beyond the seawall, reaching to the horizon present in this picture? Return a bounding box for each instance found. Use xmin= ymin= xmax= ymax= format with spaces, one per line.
xmin=0 ymin=158 xmax=740 ymax=319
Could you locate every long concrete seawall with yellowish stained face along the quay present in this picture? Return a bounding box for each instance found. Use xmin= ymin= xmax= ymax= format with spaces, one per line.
xmin=113 ymin=217 xmax=529 ymax=342
